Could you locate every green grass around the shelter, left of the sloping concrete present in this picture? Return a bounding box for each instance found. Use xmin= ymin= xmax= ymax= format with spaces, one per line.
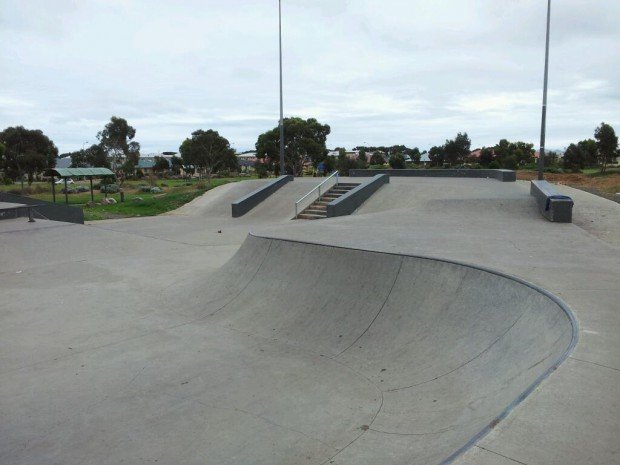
xmin=0 ymin=177 xmax=250 ymax=221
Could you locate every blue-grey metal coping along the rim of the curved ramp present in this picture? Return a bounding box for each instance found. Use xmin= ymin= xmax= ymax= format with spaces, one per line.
xmin=248 ymin=232 xmax=579 ymax=465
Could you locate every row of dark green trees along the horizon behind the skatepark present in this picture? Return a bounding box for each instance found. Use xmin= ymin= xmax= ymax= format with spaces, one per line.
xmin=0 ymin=116 xmax=620 ymax=183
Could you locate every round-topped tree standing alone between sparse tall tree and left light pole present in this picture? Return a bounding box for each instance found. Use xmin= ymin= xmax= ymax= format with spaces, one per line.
xmin=179 ymin=129 xmax=239 ymax=182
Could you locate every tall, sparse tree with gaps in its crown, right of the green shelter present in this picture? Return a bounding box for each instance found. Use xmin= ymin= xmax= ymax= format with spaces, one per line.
xmin=97 ymin=116 xmax=140 ymax=171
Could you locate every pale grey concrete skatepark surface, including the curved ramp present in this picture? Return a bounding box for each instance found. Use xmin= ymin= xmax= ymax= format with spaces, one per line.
xmin=0 ymin=178 xmax=620 ymax=465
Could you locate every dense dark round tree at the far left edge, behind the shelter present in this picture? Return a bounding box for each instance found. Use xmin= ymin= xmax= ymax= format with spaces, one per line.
xmin=0 ymin=126 xmax=58 ymax=184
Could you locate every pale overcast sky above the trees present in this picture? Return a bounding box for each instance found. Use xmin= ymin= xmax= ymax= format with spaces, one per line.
xmin=0 ymin=0 xmax=620 ymax=154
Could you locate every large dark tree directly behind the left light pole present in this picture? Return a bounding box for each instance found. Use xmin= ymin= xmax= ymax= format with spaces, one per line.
xmin=256 ymin=117 xmax=331 ymax=176
